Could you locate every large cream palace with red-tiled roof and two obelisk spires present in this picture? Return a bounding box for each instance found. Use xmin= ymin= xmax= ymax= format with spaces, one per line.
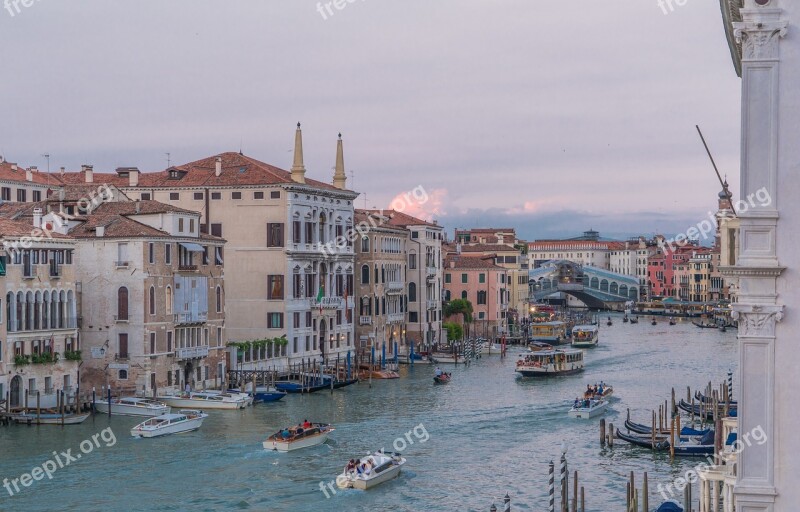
xmin=60 ymin=123 xmax=358 ymax=369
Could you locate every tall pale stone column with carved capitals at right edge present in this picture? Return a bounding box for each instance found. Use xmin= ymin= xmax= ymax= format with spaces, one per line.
xmin=724 ymin=0 xmax=791 ymax=512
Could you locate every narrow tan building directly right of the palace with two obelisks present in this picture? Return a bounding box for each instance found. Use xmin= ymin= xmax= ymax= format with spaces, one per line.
xmin=354 ymin=210 xmax=411 ymax=356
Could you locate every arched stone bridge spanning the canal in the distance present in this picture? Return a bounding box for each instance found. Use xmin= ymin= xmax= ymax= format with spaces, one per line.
xmin=528 ymin=260 xmax=639 ymax=308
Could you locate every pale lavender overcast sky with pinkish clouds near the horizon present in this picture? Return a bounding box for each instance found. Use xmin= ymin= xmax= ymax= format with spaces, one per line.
xmin=0 ymin=0 xmax=741 ymax=239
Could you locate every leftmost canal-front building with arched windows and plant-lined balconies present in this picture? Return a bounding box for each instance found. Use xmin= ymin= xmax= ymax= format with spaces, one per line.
xmin=0 ymin=216 xmax=81 ymax=408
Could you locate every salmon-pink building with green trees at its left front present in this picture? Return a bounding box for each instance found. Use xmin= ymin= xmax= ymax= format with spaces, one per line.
xmin=444 ymin=252 xmax=512 ymax=339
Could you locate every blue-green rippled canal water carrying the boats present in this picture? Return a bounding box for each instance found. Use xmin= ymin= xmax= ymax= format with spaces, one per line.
xmin=0 ymin=317 xmax=737 ymax=511
